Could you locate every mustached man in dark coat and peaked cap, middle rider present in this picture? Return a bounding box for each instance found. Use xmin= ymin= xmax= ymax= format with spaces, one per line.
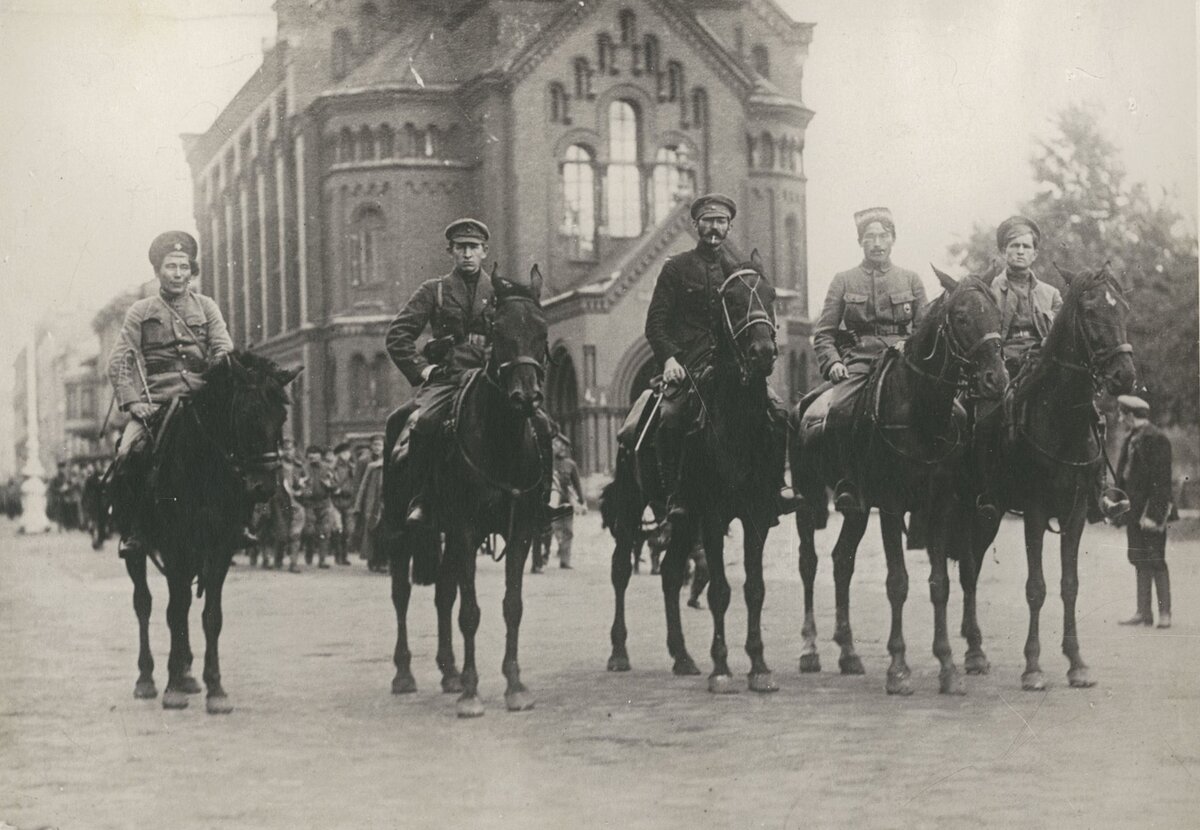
xmin=646 ymin=193 xmax=799 ymax=521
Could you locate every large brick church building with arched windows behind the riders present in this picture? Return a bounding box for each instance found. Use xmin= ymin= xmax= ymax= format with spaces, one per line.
xmin=185 ymin=0 xmax=812 ymax=473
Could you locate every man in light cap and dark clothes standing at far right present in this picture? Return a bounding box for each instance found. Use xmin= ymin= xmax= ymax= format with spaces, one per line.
xmin=1117 ymin=395 xmax=1171 ymax=628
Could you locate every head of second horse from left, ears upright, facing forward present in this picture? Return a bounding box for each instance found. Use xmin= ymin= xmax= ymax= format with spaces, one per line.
xmin=487 ymin=265 xmax=548 ymax=416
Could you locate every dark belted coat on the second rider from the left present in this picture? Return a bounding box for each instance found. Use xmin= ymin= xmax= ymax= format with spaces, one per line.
xmin=386 ymin=270 xmax=493 ymax=386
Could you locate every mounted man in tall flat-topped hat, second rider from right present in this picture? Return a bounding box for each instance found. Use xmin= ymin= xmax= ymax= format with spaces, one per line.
xmin=806 ymin=208 xmax=925 ymax=511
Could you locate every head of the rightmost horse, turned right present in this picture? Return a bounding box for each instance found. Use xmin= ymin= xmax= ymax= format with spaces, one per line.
xmin=1044 ymin=263 xmax=1138 ymax=395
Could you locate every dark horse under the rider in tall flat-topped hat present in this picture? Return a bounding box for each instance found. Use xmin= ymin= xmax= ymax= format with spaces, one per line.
xmin=791 ymin=269 xmax=1008 ymax=694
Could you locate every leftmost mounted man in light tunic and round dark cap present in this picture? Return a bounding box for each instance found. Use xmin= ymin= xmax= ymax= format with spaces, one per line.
xmin=108 ymin=230 xmax=238 ymax=557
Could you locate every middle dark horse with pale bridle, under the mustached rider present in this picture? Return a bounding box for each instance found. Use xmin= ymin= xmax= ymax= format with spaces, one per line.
xmin=600 ymin=251 xmax=785 ymax=693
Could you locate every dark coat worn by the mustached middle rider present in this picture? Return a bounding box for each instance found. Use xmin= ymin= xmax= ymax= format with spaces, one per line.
xmin=646 ymin=247 xmax=736 ymax=367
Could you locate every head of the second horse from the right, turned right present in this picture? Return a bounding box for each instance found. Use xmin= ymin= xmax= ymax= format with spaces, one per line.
xmin=913 ymin=266 xmax=1008 ymax=398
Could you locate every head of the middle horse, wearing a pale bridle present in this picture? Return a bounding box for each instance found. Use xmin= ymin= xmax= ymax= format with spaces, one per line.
xmin=718 ymin=248 xmax=779 ymax=383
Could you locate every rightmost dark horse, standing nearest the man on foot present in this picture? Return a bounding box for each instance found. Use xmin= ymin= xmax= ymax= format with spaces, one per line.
xmin=941 ymin=267 xmax=1135 ymax=691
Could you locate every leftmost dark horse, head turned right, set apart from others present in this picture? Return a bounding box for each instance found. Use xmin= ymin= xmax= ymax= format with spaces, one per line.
xmin=114 ymin=353 xmax=300 ymax=714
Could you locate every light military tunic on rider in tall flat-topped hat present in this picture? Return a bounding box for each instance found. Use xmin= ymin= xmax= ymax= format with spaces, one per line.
xmin=812 ymin=261 xmax=925 ymax=378
